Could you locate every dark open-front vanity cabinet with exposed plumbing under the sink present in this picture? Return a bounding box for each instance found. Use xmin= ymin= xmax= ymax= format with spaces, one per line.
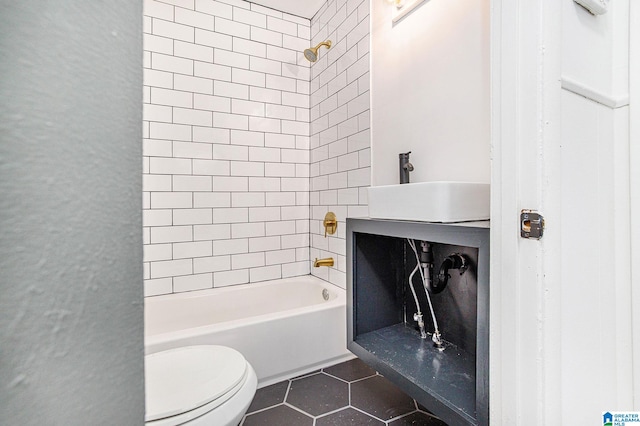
xmin=347 ymin=219 xmax=489 ymax=425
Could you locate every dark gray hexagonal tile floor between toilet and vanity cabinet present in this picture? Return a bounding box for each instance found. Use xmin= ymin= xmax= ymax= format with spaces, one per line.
xmin=240 ymin=358 xmax=446 ymax=426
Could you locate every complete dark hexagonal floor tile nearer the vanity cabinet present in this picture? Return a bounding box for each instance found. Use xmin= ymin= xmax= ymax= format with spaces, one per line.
xmin=351 ymin=376 xmax=416 ymax=421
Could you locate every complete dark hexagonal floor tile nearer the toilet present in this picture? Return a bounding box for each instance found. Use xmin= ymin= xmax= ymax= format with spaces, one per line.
xmin=287 ymin=373 xmax=349 ymax=416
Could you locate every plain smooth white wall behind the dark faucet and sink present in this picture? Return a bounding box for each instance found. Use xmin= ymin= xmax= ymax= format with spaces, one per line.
xmin=371 ymin=0 xmax=490 ymax=186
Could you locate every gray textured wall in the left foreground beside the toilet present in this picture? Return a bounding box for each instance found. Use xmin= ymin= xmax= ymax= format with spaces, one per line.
xmin=0 ymin=1 xmax=144 ymax=425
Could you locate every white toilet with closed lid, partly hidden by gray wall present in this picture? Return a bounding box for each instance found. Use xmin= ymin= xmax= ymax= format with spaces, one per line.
xmin=145 ymin=345 xmax=258 ymax=426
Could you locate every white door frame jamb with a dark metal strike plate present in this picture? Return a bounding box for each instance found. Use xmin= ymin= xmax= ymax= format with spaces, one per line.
xmin=489 ymin=0 xmax=562 ymax=424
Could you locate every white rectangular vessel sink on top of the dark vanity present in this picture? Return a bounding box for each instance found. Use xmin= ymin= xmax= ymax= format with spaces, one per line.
xmin=369 ymin=181 xmax=490 ymax=223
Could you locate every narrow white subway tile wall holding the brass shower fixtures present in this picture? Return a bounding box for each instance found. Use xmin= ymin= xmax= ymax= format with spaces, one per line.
xmin=310 ymin=0 xmax=371 ymax=288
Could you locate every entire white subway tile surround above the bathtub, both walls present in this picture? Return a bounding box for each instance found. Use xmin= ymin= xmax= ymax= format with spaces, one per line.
xmin=143 ymin=0 xmax=370 ymax=296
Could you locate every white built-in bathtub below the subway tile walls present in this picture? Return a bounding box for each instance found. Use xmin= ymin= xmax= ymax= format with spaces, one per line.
xmin=144 ymin=275 xmax=354 ymax=387
